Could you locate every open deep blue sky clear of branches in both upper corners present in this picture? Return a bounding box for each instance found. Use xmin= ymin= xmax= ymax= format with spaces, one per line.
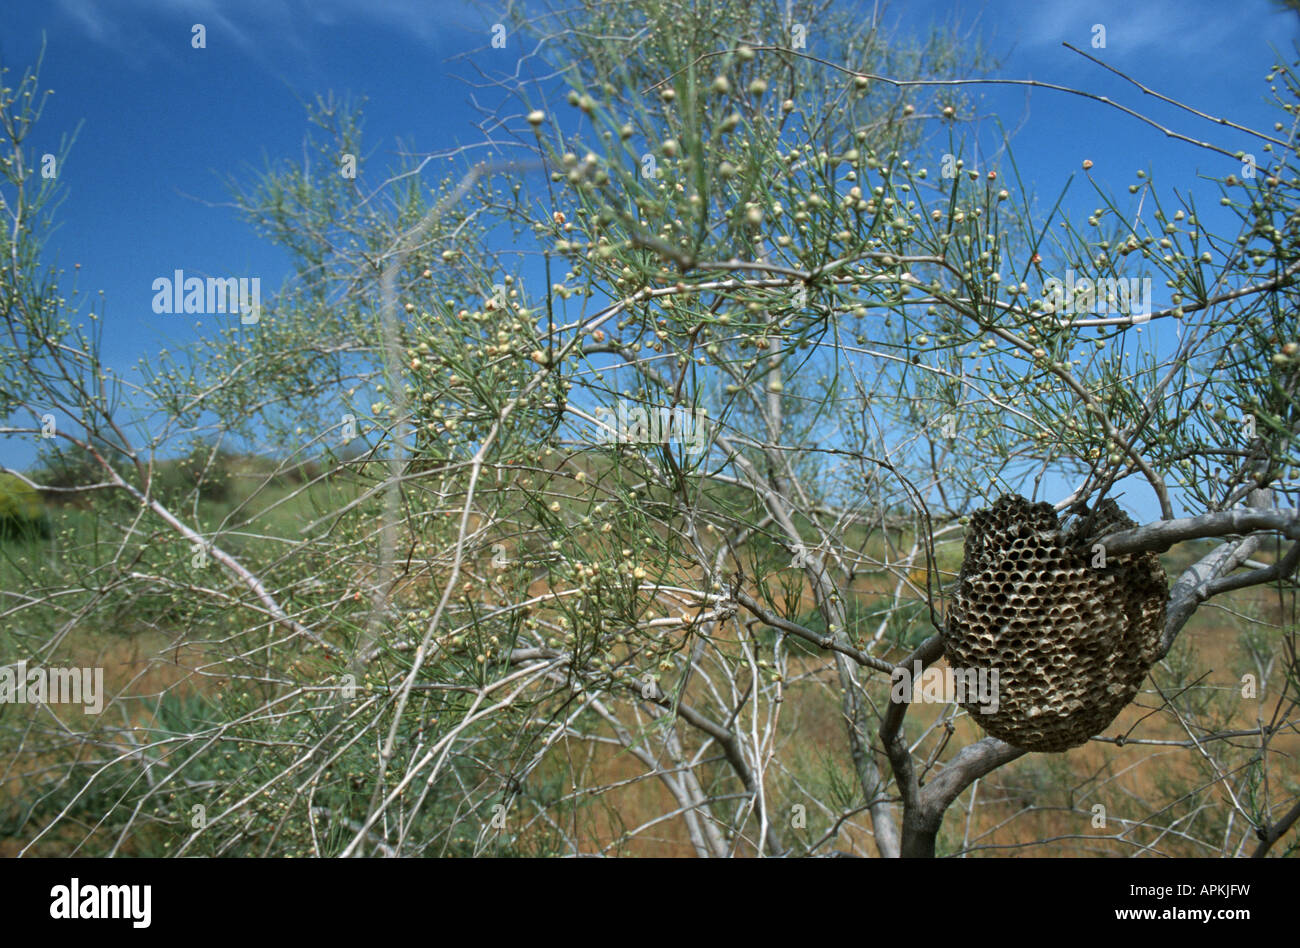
xmin=0 ymin=0 xmax=1300 ymax=517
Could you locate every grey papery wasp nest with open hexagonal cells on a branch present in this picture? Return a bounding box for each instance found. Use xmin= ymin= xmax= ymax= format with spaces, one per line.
xmin=944 ymin=495 xmax=1169 ymax=752
